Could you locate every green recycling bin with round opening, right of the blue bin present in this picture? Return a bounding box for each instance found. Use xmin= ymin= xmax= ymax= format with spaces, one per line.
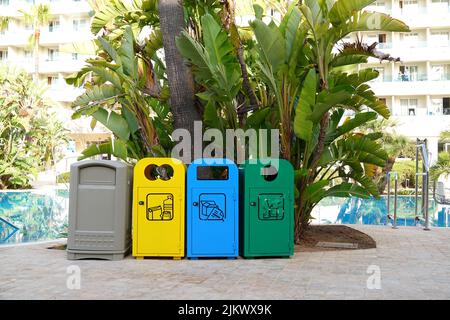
xmin=240 ymin=159 xmax=294 ymax=258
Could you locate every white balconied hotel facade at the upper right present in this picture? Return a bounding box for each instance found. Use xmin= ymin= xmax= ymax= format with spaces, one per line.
xmin=359 ymin=0 xmax=450 ymax=161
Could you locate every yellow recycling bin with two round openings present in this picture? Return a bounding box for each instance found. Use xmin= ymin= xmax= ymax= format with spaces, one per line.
xmin=133 ymin=158 xmax=186 ymax=259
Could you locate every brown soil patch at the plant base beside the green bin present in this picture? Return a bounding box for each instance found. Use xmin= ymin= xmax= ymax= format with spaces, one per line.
xmin=295 ymin=225 xmax=377 ymax=252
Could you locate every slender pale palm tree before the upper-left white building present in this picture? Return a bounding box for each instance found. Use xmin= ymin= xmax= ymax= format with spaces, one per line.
xmin=19 ymin=3 xmax=50 ymax=81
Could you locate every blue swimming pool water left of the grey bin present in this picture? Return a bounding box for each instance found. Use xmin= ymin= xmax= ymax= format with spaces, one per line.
xmin=0 ymin=189 xmax=69 ymax=245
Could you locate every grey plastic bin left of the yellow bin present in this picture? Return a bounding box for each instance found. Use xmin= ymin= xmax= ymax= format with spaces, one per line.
xmin=67 ymin=161 xmax=133 ymax=260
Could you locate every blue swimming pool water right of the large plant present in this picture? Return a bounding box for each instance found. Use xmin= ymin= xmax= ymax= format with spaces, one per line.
xmin=312 ymin=196 xmax=450 ymax=227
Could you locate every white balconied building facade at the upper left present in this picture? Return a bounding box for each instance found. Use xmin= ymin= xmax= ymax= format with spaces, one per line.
xmin=0 ymin=0 xmax=92 ymax=106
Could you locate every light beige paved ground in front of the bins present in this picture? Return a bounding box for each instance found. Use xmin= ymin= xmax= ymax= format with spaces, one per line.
xmin=0 ymin=227 xmax=450 ymax=299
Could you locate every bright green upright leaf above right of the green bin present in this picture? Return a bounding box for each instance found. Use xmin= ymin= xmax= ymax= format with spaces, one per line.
xmin=294 ymin=69 xmax=317 ymax=141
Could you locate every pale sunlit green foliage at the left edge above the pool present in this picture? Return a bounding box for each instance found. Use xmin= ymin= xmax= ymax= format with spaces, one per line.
xmin=0 ymin=67 xmax=67 ymax=189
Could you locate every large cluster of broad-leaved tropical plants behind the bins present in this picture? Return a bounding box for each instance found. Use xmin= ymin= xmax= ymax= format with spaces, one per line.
xmin=69 ymin=0 xmax=409 ymax=239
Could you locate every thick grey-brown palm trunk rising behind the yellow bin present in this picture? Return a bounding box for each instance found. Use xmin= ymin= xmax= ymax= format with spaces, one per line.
xmin=158 ymin=0 xmax=201 ymax=138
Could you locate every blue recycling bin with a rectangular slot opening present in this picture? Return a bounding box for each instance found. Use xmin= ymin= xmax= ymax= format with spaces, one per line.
xmin=186 ymin=159 xmax=239 ymax=258
